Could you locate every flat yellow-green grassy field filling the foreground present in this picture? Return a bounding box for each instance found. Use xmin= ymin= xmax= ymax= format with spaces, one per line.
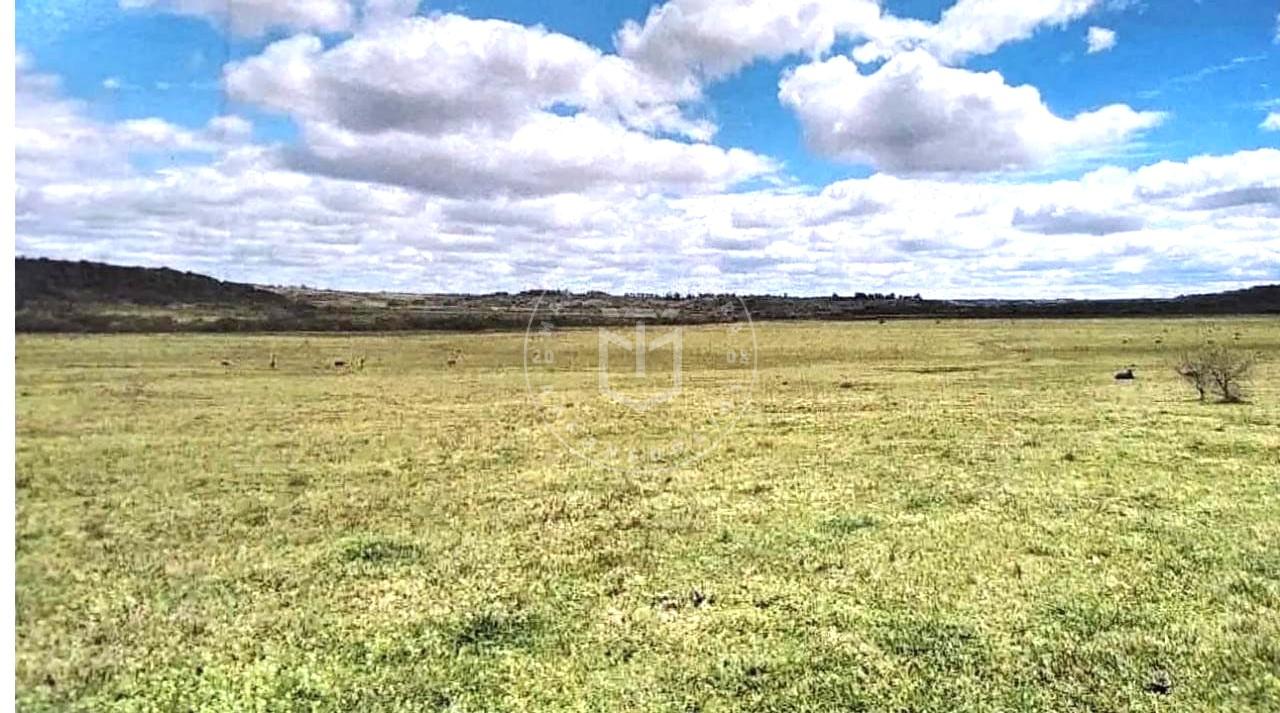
xmin=17 ymin=319 xmax=1280 ymax=712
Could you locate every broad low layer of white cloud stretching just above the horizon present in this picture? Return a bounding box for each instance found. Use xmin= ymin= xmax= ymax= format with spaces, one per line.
xmin=17 ymin=56 xmax=1280 ymax=297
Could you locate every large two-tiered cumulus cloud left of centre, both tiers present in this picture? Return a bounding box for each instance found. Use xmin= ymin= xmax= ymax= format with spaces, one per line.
xmin=225 ymin=15 xmax=776 ymax=196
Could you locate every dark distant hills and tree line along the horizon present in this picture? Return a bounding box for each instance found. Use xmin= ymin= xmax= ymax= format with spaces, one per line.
xmin=15 ymin=257 xmax=1280 ymax=332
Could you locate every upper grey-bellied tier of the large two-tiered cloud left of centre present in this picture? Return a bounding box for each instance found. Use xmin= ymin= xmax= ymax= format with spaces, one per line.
xmin=225 ymin=15 xmax=707 ymax=134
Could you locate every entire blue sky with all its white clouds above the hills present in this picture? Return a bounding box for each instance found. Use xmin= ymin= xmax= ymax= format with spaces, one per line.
xmin=17 ymin=0 xmax=1280 ymax=294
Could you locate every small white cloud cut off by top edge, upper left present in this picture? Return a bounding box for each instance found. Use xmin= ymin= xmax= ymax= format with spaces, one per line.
xmin=120 ymin=0 xmax=355 ymax=37
